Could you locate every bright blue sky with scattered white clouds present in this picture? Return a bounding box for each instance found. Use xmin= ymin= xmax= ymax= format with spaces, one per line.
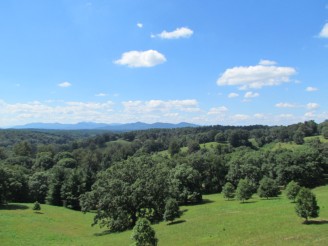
xmin=0 ymin=0 xmax=328 ymax=127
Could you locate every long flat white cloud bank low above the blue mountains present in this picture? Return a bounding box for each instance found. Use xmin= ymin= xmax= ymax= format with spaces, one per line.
xmin=122 ymin=99 xmax=200 ymax=114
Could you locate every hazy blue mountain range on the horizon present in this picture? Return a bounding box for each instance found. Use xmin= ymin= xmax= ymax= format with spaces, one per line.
xmin=12 ymin=122 xmax=198 ymax=131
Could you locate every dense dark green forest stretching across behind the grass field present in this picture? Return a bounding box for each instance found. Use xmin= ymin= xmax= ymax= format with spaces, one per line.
xmin=0 ymin=121 xmax=328 ymax=231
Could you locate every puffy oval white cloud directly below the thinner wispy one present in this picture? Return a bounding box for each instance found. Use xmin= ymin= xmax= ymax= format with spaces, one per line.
xmin=114 ymin=50 xmax=166 ymax=67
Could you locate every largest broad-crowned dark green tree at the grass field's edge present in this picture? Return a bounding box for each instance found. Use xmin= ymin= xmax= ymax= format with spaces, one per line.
xmin=81 ymin=156 xmax=168 ymax=231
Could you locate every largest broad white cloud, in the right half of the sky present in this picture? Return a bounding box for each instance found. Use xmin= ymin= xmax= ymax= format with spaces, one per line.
xmin=217 ymin=60 xmax=296 ymax=90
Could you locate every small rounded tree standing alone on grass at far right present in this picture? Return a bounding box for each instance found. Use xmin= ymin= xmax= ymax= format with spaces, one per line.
xmin=295 ymin=188 xmax=320 ymax=222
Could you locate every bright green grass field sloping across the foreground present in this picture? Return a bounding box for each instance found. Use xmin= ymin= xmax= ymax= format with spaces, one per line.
xmin=0 ymin=186 xmax=328 ymax=246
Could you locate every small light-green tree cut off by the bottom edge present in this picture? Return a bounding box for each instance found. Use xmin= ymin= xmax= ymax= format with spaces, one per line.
xmin=131 ymin=218 xmax=158 ymax=246
